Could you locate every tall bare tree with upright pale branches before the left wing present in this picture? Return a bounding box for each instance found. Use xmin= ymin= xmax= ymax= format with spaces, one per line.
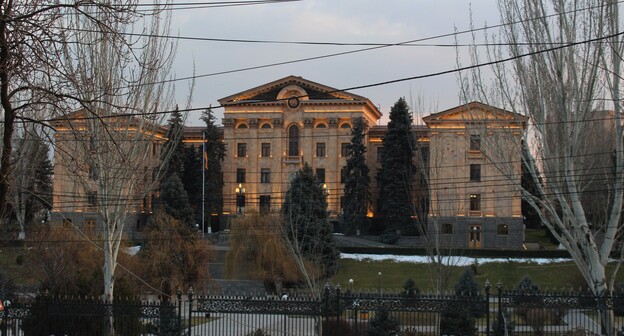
xmin=55 ymin=3 xmax=190 ymax=308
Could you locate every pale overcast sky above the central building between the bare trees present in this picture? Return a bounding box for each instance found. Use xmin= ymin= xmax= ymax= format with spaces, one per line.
xmin=167 ymin=0 xmax=499 ymax=124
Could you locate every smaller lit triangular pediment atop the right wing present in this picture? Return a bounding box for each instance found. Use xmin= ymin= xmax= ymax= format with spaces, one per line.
xmin=423 ymin=102 xmax=528 ymax=125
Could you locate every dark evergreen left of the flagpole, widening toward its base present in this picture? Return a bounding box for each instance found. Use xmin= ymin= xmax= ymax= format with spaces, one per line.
xmin=159 ymin=108 xmax=195 ymax=227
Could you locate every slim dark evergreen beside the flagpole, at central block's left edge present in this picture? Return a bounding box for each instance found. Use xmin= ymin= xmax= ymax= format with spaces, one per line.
xmin=201 ymin=109 xmax=225 ymax=225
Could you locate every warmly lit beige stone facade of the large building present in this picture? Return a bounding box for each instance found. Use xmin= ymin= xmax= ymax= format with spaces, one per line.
xmin=53 ymin=76 xmax=527 ymax=249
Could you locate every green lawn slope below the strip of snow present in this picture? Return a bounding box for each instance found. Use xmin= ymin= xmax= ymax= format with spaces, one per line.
xmin=332 ymin=259 xmax=624 ymax=292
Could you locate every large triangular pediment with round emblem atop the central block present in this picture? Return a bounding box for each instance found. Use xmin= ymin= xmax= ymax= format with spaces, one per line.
xmin=219 ymin=76 xmax=368 ymax=105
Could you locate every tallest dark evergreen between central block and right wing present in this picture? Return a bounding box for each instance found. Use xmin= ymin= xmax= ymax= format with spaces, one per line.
xmin=377 ymin=98 xmax=416 ymax=243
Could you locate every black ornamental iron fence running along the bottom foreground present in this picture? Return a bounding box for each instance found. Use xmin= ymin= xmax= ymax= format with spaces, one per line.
xmin=0 ymin=288 xmax=624 ymax=336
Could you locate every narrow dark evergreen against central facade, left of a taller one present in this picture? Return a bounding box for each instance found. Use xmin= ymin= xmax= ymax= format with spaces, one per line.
xmin=343 ymin=118 xmax=370 ymax=234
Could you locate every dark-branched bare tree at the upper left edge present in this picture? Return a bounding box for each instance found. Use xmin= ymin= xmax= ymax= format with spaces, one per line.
xmin=0 ymin=0 xmax=145 ymax=226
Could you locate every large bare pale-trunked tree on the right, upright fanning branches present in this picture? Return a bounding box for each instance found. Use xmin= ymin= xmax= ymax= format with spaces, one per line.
xmin=460 ymin=0 xmax=624 ymax=335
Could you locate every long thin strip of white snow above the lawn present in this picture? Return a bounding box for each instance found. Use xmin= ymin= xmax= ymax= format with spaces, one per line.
xmin=340 ymin=253 xmax=571 ymax=266
